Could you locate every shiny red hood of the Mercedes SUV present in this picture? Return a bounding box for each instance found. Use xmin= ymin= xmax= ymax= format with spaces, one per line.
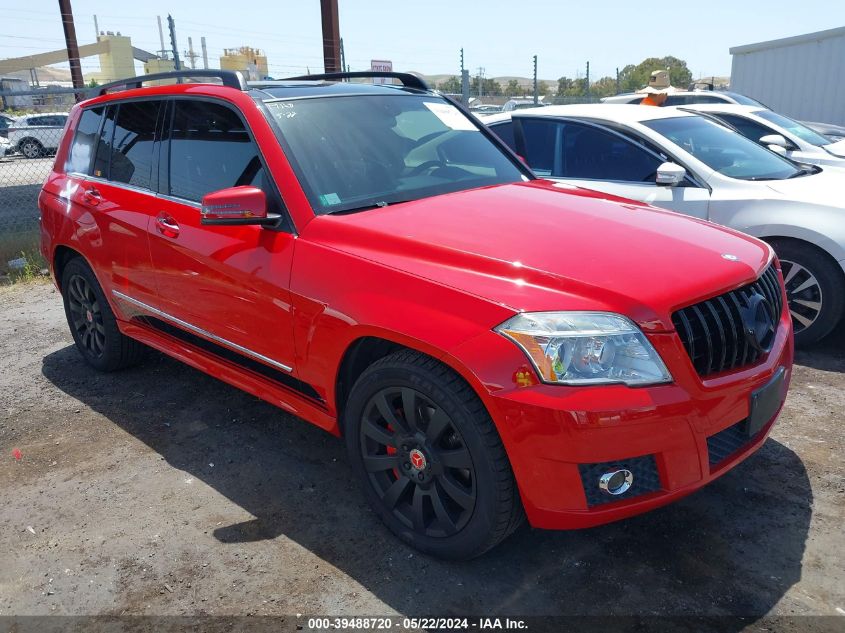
xmin=301 ymin=180 xmax=771 ymax=330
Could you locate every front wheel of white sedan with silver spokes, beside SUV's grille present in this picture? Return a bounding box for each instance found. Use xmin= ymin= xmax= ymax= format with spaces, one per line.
xmin=771 ymin=240 xmax=845 ymax=346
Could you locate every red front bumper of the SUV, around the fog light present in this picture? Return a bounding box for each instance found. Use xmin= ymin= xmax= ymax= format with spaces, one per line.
xmin=454 ymin=310 xmax=793 ymax=529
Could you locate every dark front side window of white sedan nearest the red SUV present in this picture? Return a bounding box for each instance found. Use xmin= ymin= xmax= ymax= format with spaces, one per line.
xmin=561 ymin=123 xmax=660 ymax=182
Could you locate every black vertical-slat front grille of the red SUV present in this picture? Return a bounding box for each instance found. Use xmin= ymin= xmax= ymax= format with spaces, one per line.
xmin=672 ymin=264 xmax=783 ymax=376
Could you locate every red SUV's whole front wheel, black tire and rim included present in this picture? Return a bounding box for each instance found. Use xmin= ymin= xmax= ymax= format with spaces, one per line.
xmin=344 ymin=350 xmax=523 ymax=559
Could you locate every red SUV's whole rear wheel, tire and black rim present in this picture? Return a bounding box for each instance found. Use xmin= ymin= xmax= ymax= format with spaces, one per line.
xmin=62 ymin=257 xmax=145 ymax=371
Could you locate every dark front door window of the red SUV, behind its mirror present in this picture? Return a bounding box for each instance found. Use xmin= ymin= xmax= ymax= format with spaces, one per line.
xmin=169 ymin=100 xmax=261 ymax=202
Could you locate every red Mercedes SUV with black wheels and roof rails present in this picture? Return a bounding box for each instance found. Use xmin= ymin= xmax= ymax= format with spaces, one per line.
xmin=40 ymin=72 xmax=793 ymax=558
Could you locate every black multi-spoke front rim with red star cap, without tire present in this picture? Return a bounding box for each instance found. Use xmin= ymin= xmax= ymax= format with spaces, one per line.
xmin=360 ymin=387 xmax=476 ymax=537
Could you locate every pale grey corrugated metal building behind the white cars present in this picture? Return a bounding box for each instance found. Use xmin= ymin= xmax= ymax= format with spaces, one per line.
xmin=730 ymin=27 xmax=845 ymax=125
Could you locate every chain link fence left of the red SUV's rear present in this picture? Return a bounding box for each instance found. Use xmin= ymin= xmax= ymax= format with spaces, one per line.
xmin=0 ymin=89 xmax=74 ymax=266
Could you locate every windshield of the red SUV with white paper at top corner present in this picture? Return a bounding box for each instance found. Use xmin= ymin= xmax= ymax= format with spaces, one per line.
xmin=266 ymin=94 xmax=526 ymax=214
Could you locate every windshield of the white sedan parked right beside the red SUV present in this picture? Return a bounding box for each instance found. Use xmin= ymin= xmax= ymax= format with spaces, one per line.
xmin=643 ymin=116 xmax=804 ymax=180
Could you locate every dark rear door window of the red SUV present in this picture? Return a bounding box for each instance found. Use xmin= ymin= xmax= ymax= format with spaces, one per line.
xmin=109 ymin=101 xmax=159 ymax=189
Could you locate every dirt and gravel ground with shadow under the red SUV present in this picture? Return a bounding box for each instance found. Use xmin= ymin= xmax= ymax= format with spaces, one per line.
xmin=0 ymin=283 xmax=845 ymax=630
